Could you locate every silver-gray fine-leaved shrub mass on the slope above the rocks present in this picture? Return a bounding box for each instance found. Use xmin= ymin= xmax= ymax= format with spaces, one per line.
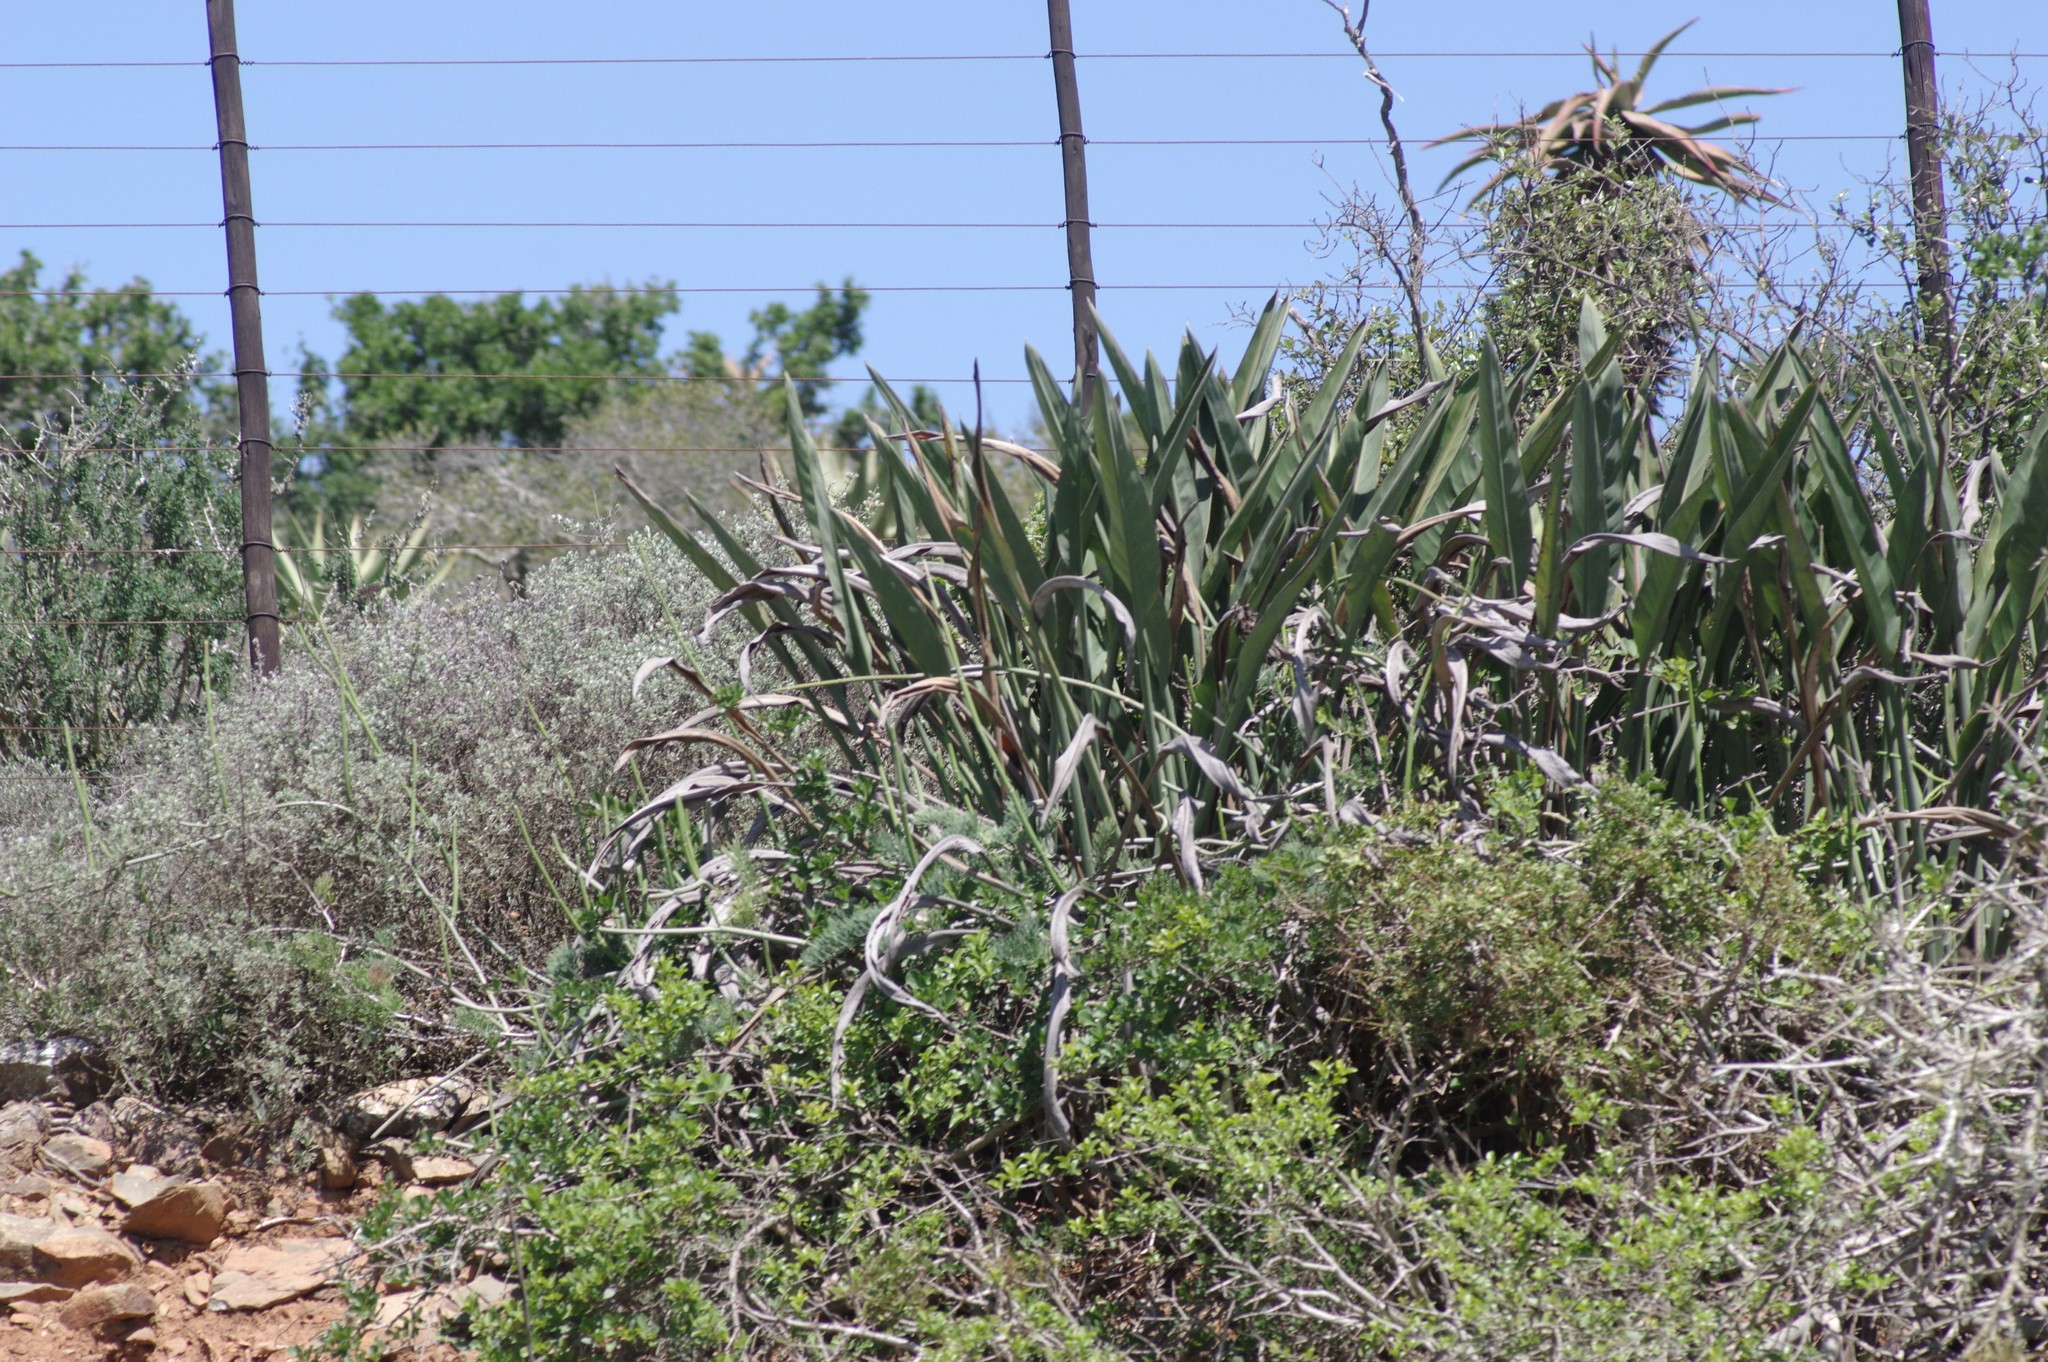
xmin=0 ymin=537 xmax=753 ymax=1110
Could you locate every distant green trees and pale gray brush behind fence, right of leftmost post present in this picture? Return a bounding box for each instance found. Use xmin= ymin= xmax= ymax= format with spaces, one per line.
xmin=285 ymin=281 xmax=868 ymax=584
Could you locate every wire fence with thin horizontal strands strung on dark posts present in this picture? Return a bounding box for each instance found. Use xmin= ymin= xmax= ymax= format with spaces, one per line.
xmin=0 ymin=0 xmax=2048 ymax=782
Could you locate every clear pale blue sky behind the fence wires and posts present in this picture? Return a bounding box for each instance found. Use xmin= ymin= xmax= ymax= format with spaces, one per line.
xmin=0 ymin=0 xmax=2048 ymax=422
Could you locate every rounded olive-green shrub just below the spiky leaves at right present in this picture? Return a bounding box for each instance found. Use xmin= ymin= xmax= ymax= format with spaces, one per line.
xmin=1321 ymin=782 xmax=1862 ymax=1151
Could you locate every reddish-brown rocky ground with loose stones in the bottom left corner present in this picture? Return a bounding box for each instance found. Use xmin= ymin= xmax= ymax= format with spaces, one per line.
xmin=0 ymin=1065 xmax=495 ymax=1362
